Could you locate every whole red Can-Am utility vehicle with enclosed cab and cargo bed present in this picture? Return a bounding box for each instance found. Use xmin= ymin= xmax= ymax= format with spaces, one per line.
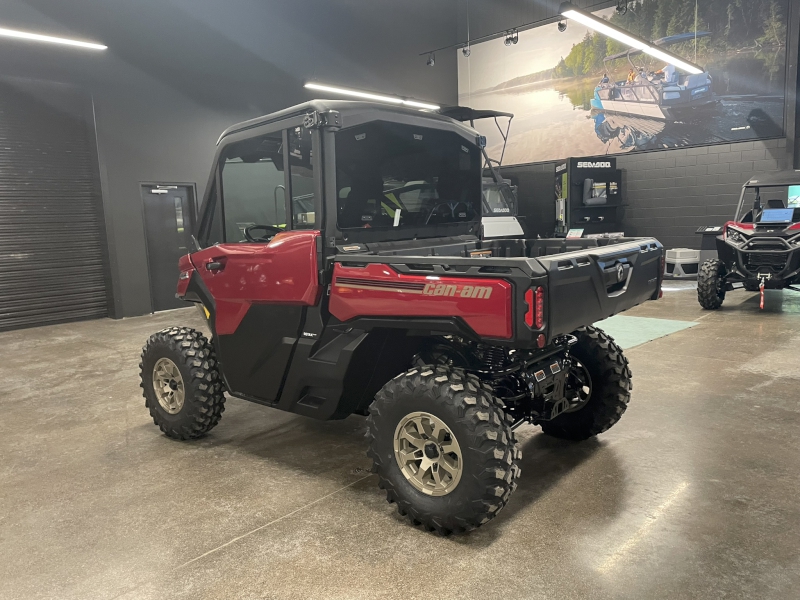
xmin=141 ymin=101 xmax=663 ymax=534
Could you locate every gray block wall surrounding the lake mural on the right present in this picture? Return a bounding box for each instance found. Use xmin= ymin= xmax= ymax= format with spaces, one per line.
xmin=460 ymin=0 xmax=800 ymax=248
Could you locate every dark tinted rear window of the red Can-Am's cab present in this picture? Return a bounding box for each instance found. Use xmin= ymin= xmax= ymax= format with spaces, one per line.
xmin=336 ymin=121 xmax=482 ymax=229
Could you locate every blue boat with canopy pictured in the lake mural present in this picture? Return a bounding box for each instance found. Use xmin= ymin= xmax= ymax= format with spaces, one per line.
xmin=591 ymin=31 xmax=717 ymax=121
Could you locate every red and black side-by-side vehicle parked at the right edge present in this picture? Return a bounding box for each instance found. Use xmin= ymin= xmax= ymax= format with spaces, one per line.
xmin=697 ymin=171 xmax=800 ymax=309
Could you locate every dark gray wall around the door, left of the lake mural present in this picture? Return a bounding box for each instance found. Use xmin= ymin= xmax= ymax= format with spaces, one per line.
xmin=0 ymin=0 xmax=457 ymax=317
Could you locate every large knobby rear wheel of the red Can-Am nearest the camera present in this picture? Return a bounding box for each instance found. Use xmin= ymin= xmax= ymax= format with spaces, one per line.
xmin=367 ymin=365 xmax=522 ymax=535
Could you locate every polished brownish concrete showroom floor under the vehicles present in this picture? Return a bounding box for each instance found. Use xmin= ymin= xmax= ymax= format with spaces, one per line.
xmin=0 ymin=284 xmax=800 ymax=600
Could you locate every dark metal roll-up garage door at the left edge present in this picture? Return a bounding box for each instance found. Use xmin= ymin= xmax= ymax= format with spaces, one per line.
xmin=0 ymin=80 xmax=108 ymax=331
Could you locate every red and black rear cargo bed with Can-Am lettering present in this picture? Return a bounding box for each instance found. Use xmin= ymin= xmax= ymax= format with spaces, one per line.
xmin=334 ymin=238 xmax=663 ymax=346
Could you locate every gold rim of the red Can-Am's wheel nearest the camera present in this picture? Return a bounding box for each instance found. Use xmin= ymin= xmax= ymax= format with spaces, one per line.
xmin=394 ymin=412 xmax=464 ymax=496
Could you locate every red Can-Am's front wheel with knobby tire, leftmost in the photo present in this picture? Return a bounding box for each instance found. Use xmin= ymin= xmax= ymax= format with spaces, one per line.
xmin=139 ymin=327 xmax=225 ymax=440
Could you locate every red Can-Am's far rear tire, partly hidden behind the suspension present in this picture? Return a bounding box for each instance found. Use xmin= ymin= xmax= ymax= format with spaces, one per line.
xmin=542 ymin=327 xmax=633 ymax=440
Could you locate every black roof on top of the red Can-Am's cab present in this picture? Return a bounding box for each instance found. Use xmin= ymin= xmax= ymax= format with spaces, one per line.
xmin=217 ymin=100 xmax=478 ymax=144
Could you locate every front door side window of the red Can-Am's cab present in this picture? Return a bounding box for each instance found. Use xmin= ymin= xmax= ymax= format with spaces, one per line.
xmin=220 ymin=132 xmax=287 ymax=244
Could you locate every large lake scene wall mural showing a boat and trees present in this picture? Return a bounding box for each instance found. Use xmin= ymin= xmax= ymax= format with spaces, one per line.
xmin=458 ymin=0 xmax=788 ymax=164
